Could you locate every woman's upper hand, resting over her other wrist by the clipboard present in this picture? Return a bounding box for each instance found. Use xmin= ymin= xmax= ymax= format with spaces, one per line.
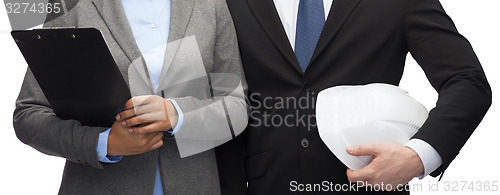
xmin=116 ymin=95 xmax=177 ymax=133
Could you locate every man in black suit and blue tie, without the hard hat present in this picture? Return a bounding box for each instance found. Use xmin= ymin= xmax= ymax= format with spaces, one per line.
xmin=219 ymin=0 xmax=491 ymax=194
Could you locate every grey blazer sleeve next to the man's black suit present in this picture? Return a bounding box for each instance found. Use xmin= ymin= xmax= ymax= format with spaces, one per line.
xmin=173 ymin=0 xmax=248 ymax=157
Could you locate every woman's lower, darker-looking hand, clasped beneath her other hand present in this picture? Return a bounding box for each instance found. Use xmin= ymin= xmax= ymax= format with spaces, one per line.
xmin=108 ymin=121 xmax=163 ymax=156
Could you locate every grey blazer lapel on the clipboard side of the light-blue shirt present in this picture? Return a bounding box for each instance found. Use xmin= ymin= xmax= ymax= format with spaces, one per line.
xmin=92 ymin=0 xmax=154 ymax=91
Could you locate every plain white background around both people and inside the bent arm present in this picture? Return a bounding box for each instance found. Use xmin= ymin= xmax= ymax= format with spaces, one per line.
xmin=0 ymin=0 xmax=500 ymax=195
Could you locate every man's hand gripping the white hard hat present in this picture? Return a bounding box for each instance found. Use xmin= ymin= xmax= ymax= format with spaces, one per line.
xmin=347 ymin=143 xmax=424 ymax=190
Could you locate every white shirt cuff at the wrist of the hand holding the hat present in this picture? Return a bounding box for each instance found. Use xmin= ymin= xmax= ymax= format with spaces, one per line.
xmin=406 ymin=139 xmax=443 ymax=179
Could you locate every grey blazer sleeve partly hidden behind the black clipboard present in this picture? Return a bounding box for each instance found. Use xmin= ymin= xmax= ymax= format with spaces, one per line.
xmin=13 ymin=8 xmax=108 ymax=169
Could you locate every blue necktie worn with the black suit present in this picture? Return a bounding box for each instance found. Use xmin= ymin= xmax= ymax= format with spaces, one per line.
xmin=295 ymin=0 xmax=325 ymax=72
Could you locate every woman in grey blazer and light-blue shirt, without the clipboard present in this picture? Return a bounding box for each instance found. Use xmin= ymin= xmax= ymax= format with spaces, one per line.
xmin=14 ymin=0 xmax=248 ymax=194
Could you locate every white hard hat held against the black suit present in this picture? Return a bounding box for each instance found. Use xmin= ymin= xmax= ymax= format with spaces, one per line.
xmin=316 ymin=83 xmax=428 ymax=170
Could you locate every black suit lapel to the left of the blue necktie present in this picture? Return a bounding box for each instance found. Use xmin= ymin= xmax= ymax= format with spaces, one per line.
xmin=247 ymin=0 xmax=303 ymax=74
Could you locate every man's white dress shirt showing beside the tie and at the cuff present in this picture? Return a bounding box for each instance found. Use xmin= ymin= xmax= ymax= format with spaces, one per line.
xmin=273 ymin=0 xmax=443 ymax=179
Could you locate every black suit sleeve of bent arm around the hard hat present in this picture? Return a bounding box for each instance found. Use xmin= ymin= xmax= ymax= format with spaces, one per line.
xmin=404 ymin=0 xmax=492 ymax=177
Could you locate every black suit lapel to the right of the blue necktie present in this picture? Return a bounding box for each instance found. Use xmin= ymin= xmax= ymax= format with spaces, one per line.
xmin=310 ymin=0 xmax=361 ymax=65
